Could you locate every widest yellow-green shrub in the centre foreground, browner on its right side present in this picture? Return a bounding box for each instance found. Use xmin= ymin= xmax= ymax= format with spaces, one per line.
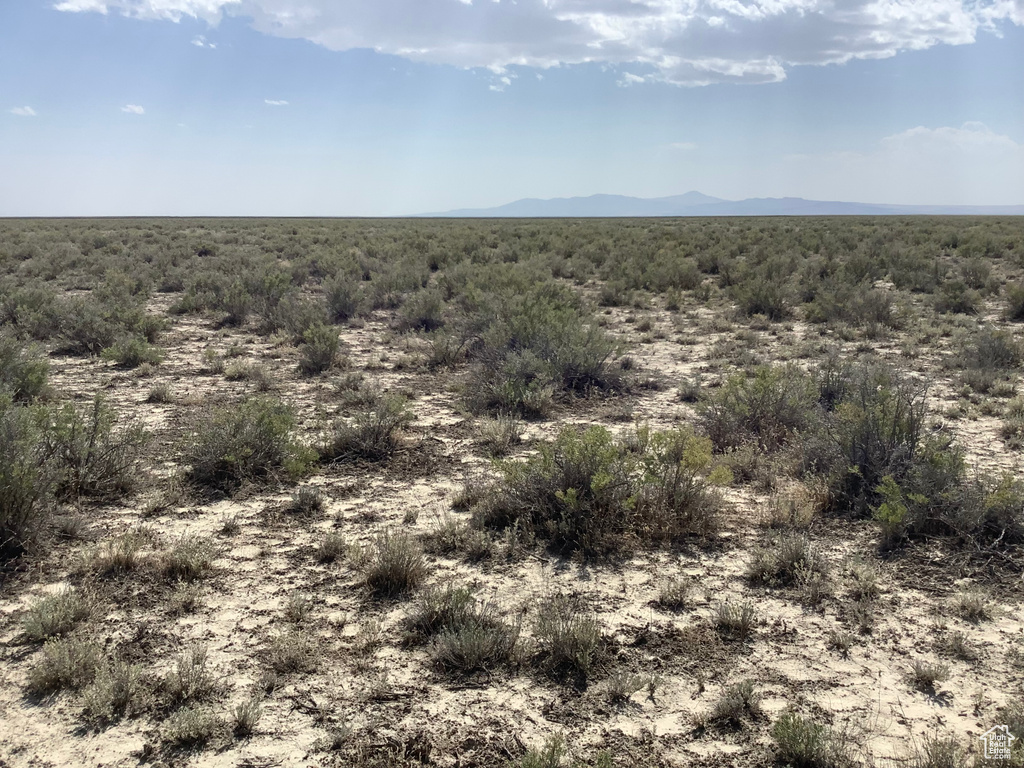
xmin=474 ymin=427 xmax=718 ymax=556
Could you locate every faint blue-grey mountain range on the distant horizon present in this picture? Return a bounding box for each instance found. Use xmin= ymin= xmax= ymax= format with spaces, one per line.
xmin=420 ymin=191 xmax=1024 ymax=218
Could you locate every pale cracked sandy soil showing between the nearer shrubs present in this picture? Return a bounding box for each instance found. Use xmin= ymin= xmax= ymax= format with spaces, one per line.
xmin=0 ymin=288 xmax=1024 ymax=768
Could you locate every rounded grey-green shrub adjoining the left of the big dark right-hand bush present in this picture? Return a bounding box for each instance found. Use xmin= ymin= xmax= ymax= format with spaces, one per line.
xmin=698 ymin=366 xmax=817 ymax=452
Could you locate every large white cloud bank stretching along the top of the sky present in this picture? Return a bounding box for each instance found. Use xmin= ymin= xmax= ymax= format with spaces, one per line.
xmin=54 ymin=0 xmax=1024 ymax=85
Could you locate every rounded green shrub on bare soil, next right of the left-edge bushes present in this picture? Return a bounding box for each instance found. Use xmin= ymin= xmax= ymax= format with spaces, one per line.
xmin=182 ymin=397 xmax=314 ymax=495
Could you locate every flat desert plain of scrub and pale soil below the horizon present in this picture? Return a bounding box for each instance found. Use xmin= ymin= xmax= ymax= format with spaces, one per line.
xmin=0 ymin=218 xmax=1024 ymax=768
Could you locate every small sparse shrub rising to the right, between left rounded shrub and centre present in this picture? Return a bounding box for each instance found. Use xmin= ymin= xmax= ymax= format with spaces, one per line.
xmin=321 ymin=393 xmax=413 ymax=461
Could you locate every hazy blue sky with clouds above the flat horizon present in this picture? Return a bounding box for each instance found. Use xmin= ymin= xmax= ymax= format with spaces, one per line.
xmin=0 ymin=0 xmax=1024 ymax=216
